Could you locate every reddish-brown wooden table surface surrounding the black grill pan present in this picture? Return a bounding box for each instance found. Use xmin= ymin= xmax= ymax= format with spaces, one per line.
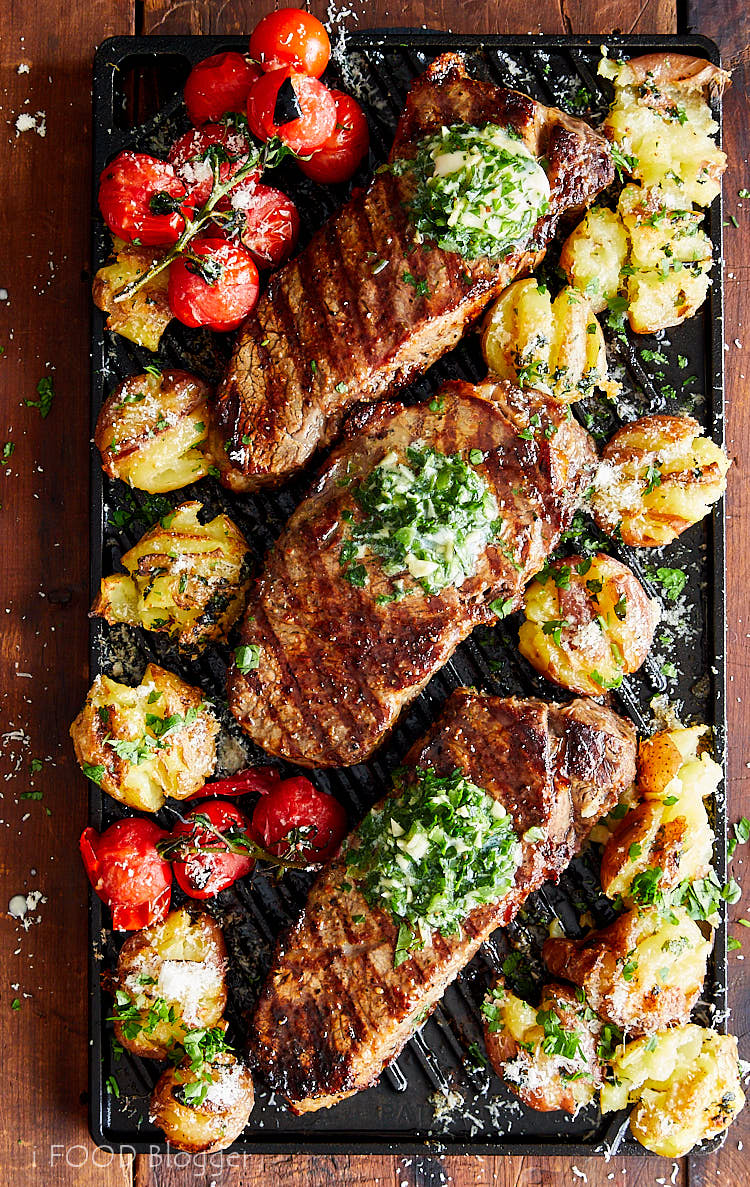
xmin=0 ymin=0 xmax=750 ymax=1187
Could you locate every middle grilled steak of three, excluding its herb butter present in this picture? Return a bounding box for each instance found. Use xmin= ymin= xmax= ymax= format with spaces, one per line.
xmin=229 ymin=381 xmax=595 ymax=767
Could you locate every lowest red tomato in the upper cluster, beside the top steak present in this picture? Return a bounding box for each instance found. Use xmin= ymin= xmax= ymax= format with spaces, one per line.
xmin=167 ymin=239 xmax=258 ymax=330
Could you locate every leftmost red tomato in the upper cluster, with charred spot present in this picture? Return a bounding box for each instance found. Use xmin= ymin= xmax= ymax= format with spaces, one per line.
xmin=98 ymin=152 xmax=192 ymax=247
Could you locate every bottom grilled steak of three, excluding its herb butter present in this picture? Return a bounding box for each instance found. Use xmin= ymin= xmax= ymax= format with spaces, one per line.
xmin=250 ymin=688 xmax=636 ymax=1113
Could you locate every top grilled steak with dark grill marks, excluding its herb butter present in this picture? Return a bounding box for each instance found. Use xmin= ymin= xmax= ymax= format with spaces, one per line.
xmin=211 ymin=55 xmax=614 ymax=490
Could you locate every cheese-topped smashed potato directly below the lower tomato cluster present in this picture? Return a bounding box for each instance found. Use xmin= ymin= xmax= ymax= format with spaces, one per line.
xmin=113 ymin=907 xmax=227 ymax=1059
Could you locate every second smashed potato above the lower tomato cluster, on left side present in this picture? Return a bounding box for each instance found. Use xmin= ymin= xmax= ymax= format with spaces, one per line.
xmin=91 ymin=501 xmax=249 ymax=654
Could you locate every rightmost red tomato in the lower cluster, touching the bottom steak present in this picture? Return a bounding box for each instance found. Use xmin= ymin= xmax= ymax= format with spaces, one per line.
xmin=253 ymin=776 xmax=347 ymax=863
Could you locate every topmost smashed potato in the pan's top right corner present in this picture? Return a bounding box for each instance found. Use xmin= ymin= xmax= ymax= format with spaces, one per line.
xmin=599 ymin=53 xmax=729 ymax=208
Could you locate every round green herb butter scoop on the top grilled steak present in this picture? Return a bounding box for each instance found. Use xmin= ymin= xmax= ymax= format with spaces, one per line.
xmin=390 ymin=123 xmax=549 ymax=259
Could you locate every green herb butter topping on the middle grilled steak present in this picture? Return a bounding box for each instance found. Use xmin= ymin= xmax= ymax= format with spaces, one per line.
xmin=339 ymin=445 xmax=500 ymax=594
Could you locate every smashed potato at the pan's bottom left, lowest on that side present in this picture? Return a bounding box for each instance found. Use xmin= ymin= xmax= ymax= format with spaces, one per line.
xmin=150 ymin=1053 xmax=255 ymax=1154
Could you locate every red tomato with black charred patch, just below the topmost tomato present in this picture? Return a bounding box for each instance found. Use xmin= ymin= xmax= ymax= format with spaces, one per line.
xmin=247 ymin=69 xmax=336 ymax=157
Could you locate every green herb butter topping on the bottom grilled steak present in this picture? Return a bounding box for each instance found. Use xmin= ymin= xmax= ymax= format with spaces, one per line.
xmin=347 ymin=767 xmax=521 ymax=967
